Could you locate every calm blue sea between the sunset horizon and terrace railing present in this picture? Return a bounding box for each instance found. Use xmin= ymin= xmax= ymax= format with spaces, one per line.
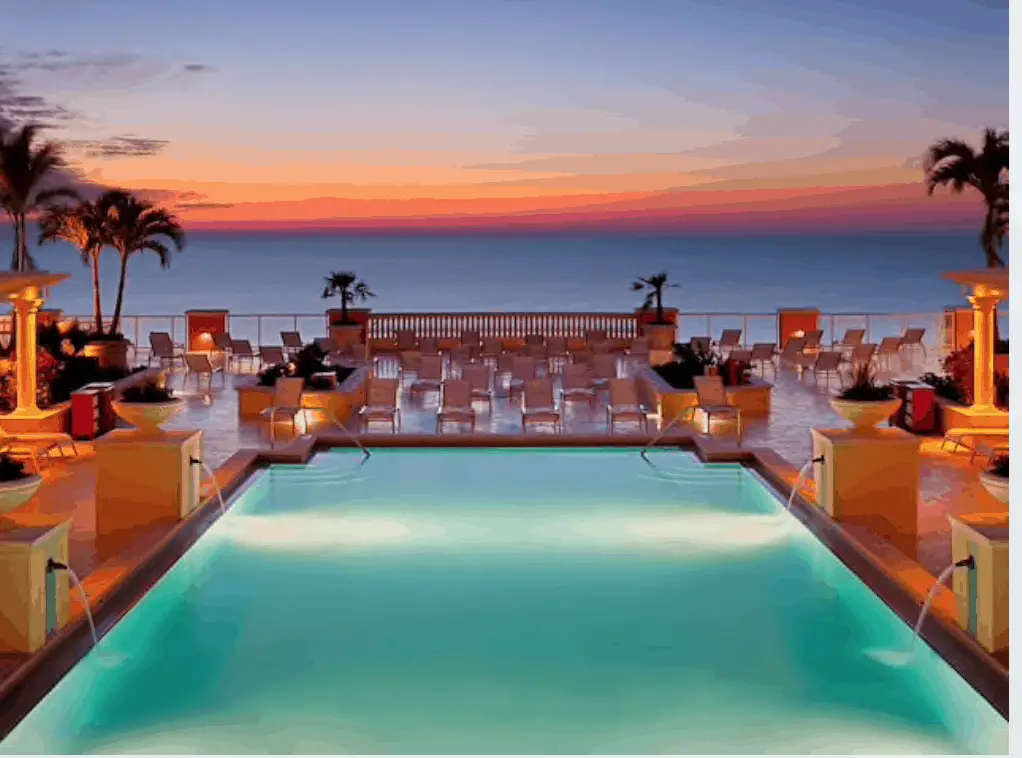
xmin=6 ymin=230 xmax=1005 ymax=315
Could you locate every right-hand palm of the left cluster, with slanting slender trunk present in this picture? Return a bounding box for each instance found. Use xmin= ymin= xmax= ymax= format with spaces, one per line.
xmin=96 ymin=190 xmax=185 ymax=335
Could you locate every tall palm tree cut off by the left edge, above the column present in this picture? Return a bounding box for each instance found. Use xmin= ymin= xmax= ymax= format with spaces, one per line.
xmin=0 ymin=124 xmax=78 ymax=271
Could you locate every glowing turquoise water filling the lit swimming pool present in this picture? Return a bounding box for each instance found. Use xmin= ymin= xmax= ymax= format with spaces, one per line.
xmin=0 ymin=449 xmax=1008 ymax=754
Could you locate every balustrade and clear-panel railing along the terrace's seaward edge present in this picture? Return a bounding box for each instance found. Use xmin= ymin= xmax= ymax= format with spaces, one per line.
xmin=49 ymin=312 xmax=1009 ymax=361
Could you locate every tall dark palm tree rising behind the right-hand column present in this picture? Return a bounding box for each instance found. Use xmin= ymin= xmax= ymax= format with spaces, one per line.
xmin=923 ymin=129 xmax=1008 ymax=269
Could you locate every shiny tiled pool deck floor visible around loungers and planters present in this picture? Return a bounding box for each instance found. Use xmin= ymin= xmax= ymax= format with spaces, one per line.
xmin=0 ymin=358 xmax=1008 ymax=702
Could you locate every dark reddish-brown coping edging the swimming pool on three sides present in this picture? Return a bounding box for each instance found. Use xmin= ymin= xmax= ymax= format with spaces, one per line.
xmin=0 ymin=432 xmax=1009 ymax=741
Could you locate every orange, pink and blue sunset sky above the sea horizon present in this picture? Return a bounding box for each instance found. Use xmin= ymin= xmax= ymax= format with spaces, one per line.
xmin=0 ymin=0 xmax=1008 ymax=229
